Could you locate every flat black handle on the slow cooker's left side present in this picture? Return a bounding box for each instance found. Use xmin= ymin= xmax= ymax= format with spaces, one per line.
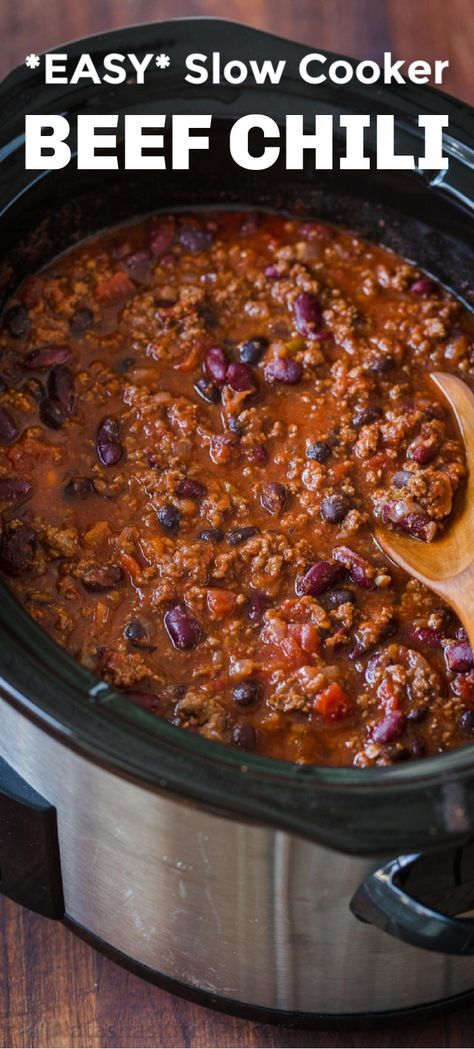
xmin=0 ymin=757 xmax=64 ymax=918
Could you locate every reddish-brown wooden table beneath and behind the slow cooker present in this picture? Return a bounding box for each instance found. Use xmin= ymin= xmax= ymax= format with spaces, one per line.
xmin=0 ymin=0 xmax=474 ymax=1049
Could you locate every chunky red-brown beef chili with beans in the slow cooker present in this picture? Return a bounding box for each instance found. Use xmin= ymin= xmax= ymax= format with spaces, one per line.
xmin=0 ymin=211 xmax=474 ymax=767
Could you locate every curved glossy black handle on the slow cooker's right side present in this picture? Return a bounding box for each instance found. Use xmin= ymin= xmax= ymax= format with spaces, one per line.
xmin=350 ymin=853 xmax=474 ymax=955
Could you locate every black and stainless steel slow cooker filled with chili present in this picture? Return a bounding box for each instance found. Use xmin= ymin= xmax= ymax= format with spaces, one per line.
xmin=0 ymin=19 xmax=474 ymax=1025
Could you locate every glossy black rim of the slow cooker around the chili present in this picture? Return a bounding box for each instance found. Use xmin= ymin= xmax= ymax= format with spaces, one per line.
xmin=0 ymin=18 xmax=474 ymax=854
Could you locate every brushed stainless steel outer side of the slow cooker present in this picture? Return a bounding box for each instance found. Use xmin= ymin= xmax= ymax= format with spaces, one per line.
xmin=0 ymin=699 xmax=474 ymax=1023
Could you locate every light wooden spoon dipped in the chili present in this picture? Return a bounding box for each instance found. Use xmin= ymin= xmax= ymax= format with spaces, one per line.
xmin=374 ymin=372 xmax=474 ymax=647
